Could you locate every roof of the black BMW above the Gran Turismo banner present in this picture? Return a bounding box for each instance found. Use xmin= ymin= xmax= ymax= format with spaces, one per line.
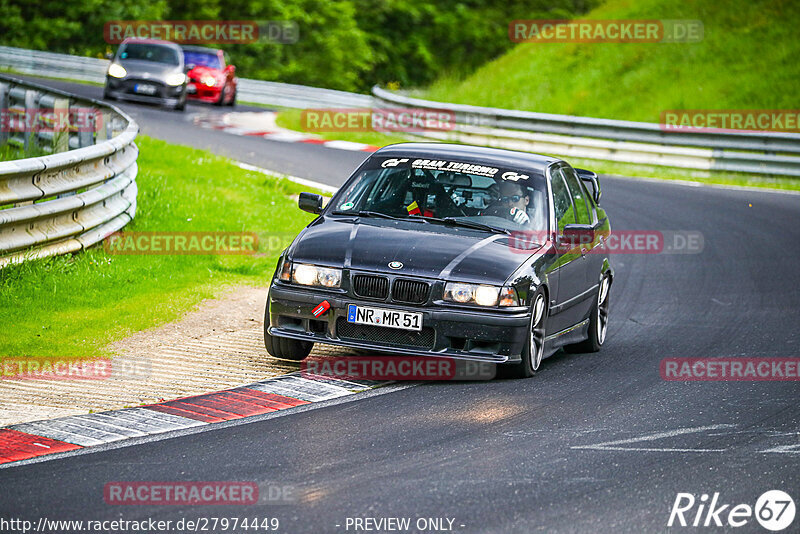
xmin=373 ymin=143 xmax=562 ymax=175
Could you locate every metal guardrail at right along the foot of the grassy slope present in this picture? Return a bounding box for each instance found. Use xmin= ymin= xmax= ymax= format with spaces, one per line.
xmin=372 ymin=86 xmax=800 ymax=176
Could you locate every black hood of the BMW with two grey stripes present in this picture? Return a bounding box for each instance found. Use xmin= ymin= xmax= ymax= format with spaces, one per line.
xmin=289 ymin=219 xmax=535 ymax=284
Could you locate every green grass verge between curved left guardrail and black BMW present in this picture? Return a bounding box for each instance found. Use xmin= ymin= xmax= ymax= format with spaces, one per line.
xmin=0 ymin=137 xmax=312 ymax=357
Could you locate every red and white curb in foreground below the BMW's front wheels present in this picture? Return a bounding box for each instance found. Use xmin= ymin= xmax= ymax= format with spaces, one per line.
xmin=0 ymin=373 xmax=386 ymax=464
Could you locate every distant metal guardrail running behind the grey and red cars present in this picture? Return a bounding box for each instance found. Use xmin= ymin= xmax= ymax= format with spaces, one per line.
xmin=0 ymin=46 xmax=373 ymax=108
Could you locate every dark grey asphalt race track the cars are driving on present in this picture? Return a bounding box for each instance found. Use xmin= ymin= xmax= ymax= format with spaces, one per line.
xmin=0 ymin=77 xmax=800 ymax=533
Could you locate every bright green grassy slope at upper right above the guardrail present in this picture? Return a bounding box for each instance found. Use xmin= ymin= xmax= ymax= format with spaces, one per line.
xmin=419 ymin=0 xmax=800 ymax=122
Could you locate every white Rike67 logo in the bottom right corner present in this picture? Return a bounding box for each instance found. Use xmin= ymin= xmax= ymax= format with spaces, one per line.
xmin=667 ymin=490 xmax=795 ymax=532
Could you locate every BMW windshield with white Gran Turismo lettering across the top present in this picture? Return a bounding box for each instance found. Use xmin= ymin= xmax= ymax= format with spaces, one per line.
xmin=329 ymin=157 xmax=548 ymax=231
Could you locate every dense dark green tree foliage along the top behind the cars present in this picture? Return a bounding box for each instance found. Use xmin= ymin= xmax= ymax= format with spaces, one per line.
xmin=0 ymin=0 xmax=596 ymax=92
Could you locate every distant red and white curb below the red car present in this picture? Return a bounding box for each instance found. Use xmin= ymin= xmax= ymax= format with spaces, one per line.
xmin=194 ymin=111 xmax=380 ymax=152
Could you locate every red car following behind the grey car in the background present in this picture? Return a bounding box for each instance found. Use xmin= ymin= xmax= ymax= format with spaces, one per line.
xmin=183 ymin=46 xmax=239 ymax=106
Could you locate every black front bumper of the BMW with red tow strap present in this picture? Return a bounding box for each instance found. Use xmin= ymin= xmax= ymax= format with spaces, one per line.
xmin=265 ymin=283 xmax=530 ymax=363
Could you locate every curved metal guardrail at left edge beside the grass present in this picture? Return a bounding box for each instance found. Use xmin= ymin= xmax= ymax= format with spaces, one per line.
xmin=0 ymin=75 xmax=139 ymax=268
